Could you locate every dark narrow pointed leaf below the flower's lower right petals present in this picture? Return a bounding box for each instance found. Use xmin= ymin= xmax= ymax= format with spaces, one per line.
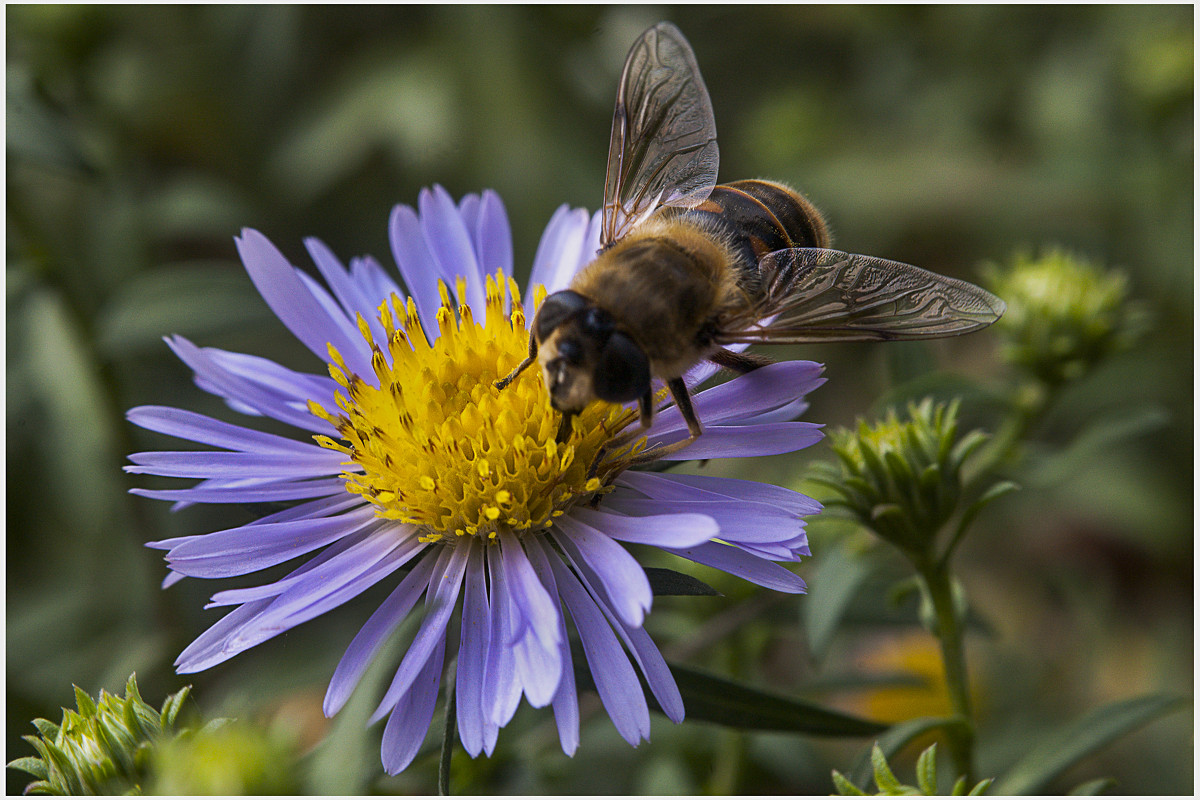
xmin=671 ymin=664 xmax=887 ymax=736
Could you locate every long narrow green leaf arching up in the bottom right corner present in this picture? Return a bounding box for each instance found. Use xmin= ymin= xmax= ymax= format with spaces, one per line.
xmin=996 ymin=694 xmax=1186 ymax=794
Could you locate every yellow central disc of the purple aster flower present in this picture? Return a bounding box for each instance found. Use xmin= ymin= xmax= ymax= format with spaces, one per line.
xmin=308 ymin=273 xmax=644 ymax=542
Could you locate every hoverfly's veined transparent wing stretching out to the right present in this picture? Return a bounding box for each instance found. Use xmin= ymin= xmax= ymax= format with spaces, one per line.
xmin=718 ymin=247 xmax=1004 ymax=344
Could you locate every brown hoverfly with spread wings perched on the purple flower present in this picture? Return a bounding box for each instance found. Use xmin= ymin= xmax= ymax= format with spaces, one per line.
xmin=497 ymin=23 xmax=1004 ymax=455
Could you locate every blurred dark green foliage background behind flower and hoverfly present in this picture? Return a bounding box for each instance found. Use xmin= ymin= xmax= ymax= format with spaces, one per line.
xmin=6 ymin=5 xmax=1194 ymax=794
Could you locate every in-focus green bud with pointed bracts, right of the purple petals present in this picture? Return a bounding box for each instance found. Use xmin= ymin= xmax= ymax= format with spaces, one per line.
xmin=812 ymin=398 xmax=986 ymax=559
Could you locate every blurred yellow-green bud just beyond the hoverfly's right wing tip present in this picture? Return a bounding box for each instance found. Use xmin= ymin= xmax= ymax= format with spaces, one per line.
xmin=990 ymin=249 xmax=1145 ymax=387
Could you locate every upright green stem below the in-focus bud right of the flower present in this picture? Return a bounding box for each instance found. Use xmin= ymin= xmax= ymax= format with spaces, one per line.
xmin=918 ymin=563 xmax=974 ymax=786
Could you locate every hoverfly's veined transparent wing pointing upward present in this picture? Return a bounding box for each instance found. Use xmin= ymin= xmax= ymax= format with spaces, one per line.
xmin=600 ymin=23 xmax=718 ymax=246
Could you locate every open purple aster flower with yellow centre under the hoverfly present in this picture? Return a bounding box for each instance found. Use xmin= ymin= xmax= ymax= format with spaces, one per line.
xmin=126 ymin=187 xmax=823 ymax=774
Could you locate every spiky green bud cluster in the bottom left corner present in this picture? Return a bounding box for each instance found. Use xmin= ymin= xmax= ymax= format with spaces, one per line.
xmin=8 ymin=675 xmax=191 ymax=794
